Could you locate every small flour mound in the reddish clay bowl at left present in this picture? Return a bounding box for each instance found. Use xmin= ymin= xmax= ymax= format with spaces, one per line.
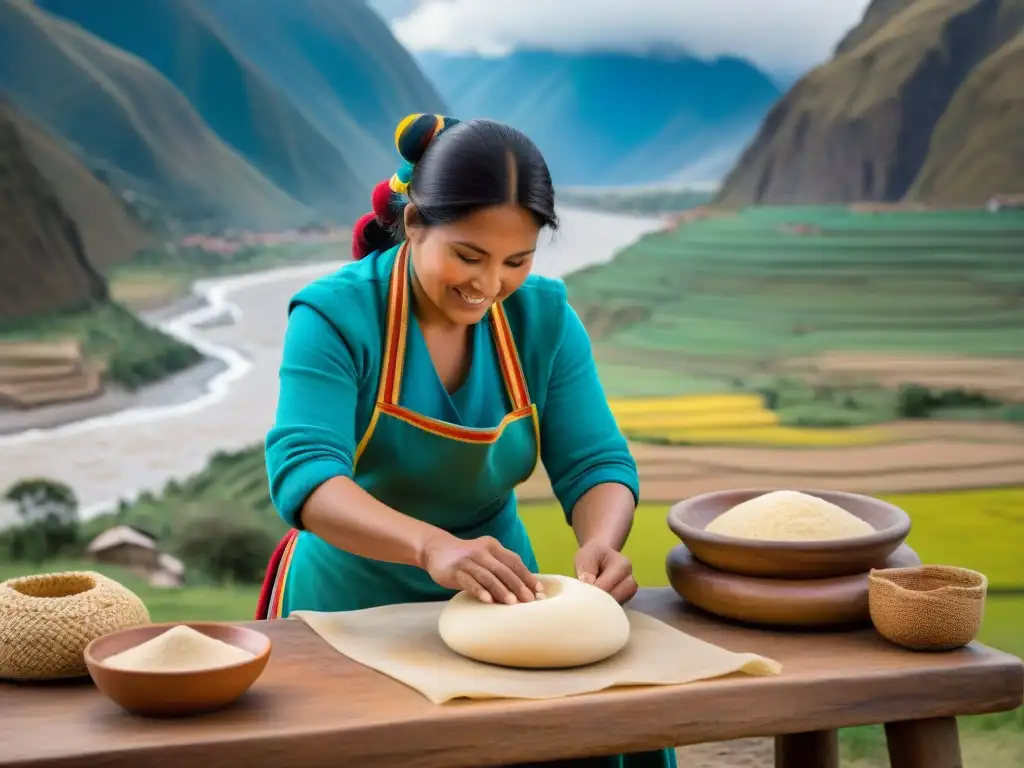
xmin=103 ymin=625 xmax=254 ymax=673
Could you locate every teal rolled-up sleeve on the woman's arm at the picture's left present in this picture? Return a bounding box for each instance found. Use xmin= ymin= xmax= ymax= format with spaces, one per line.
xmin=265 ymin=304 xmax=358 ymax=527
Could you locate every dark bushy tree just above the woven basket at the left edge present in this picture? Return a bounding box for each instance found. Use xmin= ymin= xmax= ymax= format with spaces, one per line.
xmin=3 ymin=477 xmax=79 ymax=564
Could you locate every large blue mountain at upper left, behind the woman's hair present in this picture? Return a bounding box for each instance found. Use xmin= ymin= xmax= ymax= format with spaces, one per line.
xmin=38 ymin=0 xmax=444 ymax=220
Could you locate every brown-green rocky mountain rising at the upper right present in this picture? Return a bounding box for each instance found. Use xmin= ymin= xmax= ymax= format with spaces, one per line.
xmin=717 ymin=0 xmax=1024 ymax=207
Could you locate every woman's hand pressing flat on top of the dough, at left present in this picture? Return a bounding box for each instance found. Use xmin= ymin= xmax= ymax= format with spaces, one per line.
xmin=423 ymin=532 xmax=544 ymax=605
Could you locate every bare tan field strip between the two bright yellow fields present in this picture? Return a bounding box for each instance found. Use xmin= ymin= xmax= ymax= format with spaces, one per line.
xmin=519 ymin=422 xmax=1024 ymax=502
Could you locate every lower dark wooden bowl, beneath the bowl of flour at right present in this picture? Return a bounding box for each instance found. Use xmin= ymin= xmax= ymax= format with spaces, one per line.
xmin=665 ymin=544 xmax=921 ymax=629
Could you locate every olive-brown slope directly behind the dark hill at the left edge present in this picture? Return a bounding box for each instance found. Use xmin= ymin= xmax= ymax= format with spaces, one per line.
xmin=7 ymin=110 xmax=154 ymax=271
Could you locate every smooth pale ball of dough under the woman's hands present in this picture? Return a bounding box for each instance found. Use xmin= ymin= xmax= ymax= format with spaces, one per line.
xmin=437 ymin=575 xmax=630 ymax=669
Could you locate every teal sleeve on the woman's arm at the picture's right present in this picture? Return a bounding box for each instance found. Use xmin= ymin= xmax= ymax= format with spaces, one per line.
xmin=541 ymin=302 xmax=640 ymax=523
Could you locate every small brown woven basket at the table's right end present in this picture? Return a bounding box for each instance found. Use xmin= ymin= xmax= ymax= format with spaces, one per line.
xmin=867 ymin=565 xmax=988 ymax=650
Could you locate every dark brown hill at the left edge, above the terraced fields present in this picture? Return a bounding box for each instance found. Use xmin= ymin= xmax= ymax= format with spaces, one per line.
xmin=0 ymin=103 xmax=106 ymax=322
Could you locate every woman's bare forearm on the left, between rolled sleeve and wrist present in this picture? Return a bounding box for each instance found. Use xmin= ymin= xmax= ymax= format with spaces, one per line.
xmin=301 ymin=477 xmax=451 ymax=567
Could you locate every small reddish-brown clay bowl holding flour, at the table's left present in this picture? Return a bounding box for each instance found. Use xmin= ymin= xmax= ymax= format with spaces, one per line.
xmin=85 ymin=622 xmax=270 ymax=717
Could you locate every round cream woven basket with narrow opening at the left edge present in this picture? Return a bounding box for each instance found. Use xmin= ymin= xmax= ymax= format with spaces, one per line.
xmin=0 ymin=571 xmax=150 ymax=680
